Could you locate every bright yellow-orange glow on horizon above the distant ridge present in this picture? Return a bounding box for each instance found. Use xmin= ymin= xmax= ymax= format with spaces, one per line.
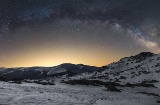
xmin=1 ymin=44 xmax=127 ymax=68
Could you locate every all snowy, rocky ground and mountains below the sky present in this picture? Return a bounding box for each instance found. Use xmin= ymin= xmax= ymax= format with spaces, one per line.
xmin=0 ymin=52 xmax=160 ymax=105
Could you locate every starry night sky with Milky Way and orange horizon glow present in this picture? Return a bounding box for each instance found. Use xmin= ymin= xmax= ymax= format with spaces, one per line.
xmin=0 ymin=0 xmax=160 ymax=67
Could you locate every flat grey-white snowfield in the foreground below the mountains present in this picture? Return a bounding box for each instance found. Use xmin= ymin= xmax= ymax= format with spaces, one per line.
xmin=0 ymin=82 xmax=160 ymax=105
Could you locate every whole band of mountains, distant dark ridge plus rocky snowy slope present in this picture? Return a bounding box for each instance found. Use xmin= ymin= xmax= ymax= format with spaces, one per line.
xmin=0 ymin=52 xmax=160 ymax=88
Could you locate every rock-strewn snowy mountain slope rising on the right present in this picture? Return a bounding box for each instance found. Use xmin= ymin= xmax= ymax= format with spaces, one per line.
xmin=71 ymin=52 xmax=160 ymax=88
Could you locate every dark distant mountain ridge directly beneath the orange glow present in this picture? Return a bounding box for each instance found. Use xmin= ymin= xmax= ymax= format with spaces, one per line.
xmin=0 ymin=63 xmax=99 ymax=79
